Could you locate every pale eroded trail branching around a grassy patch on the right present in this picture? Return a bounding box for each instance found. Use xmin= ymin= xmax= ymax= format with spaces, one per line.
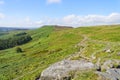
xmin=67 ymin=35 xmax=120 ymax=65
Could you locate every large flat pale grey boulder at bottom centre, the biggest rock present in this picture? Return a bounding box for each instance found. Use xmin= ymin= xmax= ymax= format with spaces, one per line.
xmin=40 ymin=60 xmax=94 ymax=80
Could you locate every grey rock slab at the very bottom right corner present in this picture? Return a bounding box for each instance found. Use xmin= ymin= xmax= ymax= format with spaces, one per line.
xmin=97 ymin=69 xmax=120 ymax=80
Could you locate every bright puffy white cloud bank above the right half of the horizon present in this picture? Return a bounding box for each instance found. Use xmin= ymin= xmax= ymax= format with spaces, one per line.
xmin=62 ymin=13 xmax=120 ymax=26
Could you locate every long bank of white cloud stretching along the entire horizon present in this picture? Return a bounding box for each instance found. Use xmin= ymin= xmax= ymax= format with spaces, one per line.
xmin=0 ymin=13 xmax=120 ymax=27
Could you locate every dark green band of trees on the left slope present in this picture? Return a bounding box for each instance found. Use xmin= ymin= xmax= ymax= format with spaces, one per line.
xmin=0 ymin=33 xmax=32 ymax=50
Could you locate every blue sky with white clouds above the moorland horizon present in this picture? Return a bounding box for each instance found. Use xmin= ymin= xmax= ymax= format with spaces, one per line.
xmin=0 ymin=0 xmax=120 ymax=28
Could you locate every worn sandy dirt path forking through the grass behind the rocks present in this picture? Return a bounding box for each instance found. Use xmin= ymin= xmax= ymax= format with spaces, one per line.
xmin=67 ymin=35 xmax=120 ymax=63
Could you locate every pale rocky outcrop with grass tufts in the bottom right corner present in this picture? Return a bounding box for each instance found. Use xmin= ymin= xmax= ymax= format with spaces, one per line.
xmin=97 ymin=60 xmax=120 ymax=80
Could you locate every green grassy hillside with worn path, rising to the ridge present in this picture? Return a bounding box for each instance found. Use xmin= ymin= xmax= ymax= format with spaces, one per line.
xmin=0 ymin=25 xmax=120 ymax=80
